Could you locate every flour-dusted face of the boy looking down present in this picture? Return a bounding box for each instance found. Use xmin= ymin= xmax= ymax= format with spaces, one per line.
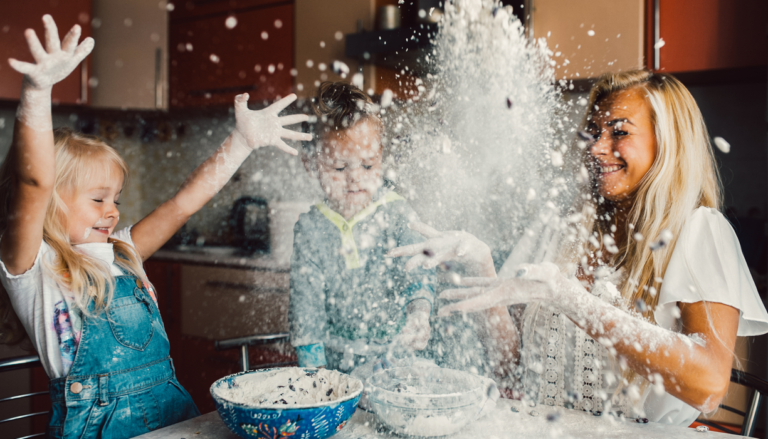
xmin=305 ymin=119 xmax=382 ymax=219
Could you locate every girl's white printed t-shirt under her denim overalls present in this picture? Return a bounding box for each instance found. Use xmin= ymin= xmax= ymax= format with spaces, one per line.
xmin=0 ymin=227 xmax=147 ymax=379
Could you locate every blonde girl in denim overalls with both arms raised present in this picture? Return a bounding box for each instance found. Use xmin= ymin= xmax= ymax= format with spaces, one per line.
xmin=0 ymin=15 xmax=308 ymax=438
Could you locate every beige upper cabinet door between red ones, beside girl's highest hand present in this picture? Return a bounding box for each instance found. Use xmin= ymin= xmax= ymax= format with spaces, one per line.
xmin=90 ymin=0 xmax=168 ymax=110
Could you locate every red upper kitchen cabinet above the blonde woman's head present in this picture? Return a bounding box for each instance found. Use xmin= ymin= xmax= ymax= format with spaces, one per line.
xmin=647 ymin=0 xmax=768 ymax=73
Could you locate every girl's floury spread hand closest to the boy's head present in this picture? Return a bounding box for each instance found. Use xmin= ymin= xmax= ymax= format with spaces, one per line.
xmin=232 ymin=93 xmax=312 ymax=155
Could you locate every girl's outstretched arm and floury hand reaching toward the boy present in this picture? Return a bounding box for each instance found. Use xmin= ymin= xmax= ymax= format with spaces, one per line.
xmin=131 ymin=93 xmax=312 ymax=259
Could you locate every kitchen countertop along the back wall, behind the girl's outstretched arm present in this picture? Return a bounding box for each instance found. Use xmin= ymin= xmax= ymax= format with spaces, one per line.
xmin=149 ymin=246 xmax=291 ymax=272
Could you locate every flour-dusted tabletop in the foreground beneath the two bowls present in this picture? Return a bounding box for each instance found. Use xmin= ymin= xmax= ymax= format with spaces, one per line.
xmin=134 ymin=399 xmax=740 ymax=439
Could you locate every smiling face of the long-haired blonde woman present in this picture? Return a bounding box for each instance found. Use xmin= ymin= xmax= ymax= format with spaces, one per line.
xmin=587 ymin=88 xmax=657 ymax=202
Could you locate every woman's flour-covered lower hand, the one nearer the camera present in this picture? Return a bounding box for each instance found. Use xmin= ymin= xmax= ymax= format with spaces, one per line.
xmin=438 ymin=262 xmax=568 ymax=317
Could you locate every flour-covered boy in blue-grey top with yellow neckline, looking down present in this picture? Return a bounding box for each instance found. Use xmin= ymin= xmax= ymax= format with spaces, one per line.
xmin=290 ymin=82 xmax=436 ymax=371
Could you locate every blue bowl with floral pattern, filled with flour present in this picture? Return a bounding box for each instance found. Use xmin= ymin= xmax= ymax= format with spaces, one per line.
xmin=211 ymin=367 xmax=363 ymax=439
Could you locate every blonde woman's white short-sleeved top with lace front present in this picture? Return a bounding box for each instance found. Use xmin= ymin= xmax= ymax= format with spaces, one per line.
xmin=499 ymin=207 xmax=768 ymax=425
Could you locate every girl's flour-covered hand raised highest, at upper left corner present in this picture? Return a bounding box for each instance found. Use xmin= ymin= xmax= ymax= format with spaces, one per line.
xmin=8 ymin=14 xmax=94 ymax=90
